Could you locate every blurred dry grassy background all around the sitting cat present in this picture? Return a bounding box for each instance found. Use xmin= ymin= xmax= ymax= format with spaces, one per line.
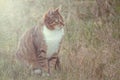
xmin=0 ymin=0 xmax=120 ymax=80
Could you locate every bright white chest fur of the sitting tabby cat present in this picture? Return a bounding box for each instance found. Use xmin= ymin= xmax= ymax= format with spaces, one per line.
xmin=43 ymin=26 xmax=64 ymax=58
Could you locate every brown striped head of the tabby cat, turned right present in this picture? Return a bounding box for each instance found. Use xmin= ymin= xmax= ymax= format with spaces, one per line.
xmin=44 ymin=8 xmax=64 ymax=30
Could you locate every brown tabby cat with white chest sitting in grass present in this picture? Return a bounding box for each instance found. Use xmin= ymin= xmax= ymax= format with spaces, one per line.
xmin=16 ymin=8 xmax=64 ymax=75
